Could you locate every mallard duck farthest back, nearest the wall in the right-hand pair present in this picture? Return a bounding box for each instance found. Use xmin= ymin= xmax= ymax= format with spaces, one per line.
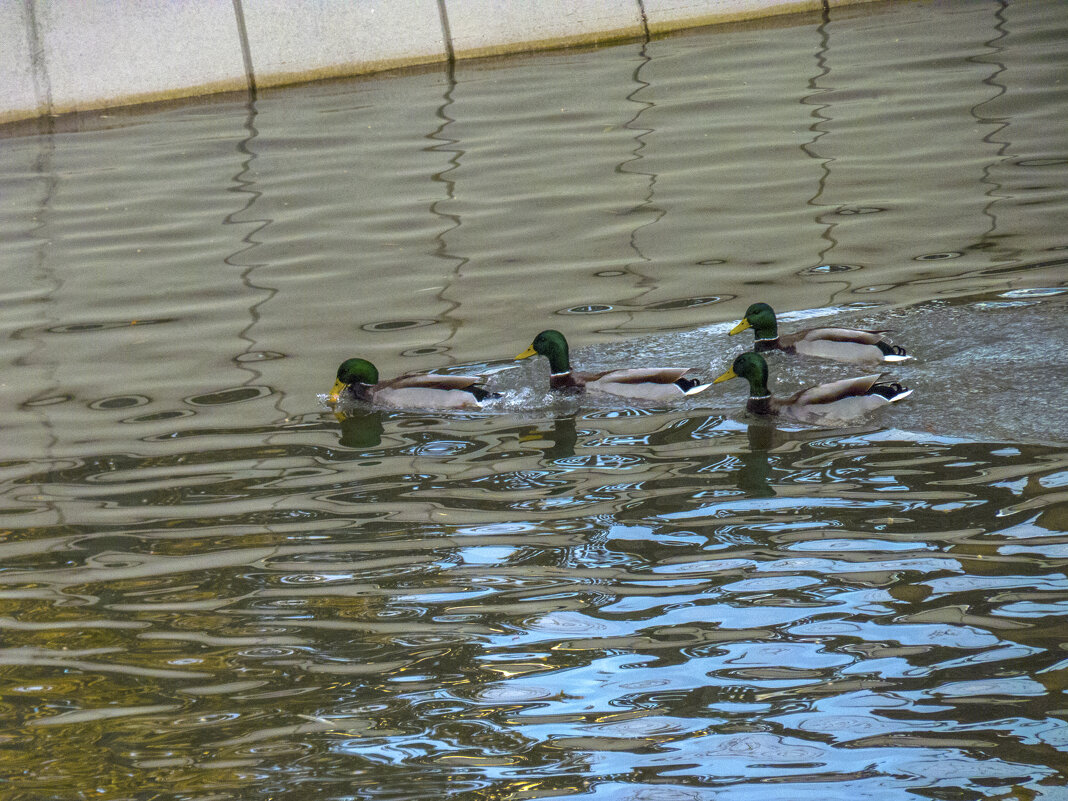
xmin=729 ymin=303 xmax=912 ymax=362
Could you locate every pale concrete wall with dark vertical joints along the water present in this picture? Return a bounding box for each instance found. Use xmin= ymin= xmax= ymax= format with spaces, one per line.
xmin=0 ymin=0 xmax=863 ymax=123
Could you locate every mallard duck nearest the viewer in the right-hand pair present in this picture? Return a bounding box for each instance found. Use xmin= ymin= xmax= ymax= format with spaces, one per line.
xmin=712 ymin=351 xmax=912 ymax=423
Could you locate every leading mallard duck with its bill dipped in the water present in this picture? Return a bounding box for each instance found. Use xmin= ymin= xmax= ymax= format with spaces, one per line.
xmin=328 ymin=359 xmax=498 ymax=409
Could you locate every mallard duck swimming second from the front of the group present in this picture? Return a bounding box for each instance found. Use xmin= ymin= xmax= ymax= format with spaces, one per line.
xmin=516 ymin=329 xmax=711 ymax=402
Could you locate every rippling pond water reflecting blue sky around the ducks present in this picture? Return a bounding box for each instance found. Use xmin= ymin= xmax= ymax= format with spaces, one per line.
xmin=0 ymin=2 xmax=1068 ymax=801
